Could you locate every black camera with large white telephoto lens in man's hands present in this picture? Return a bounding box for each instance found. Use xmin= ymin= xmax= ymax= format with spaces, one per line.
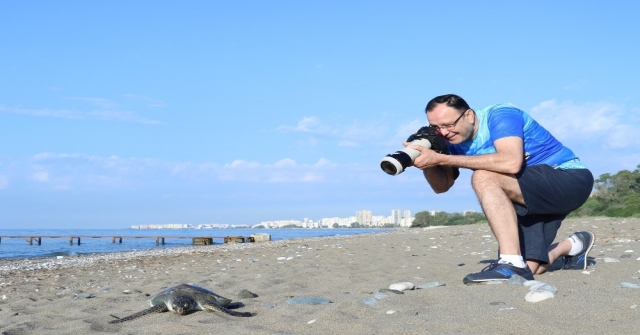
xmin=380 ymin=126 xmax=449 ymax=176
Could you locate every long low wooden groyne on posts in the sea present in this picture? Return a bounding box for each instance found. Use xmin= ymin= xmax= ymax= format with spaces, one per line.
xmin=0 ymin=235 xmax=256 ymax=245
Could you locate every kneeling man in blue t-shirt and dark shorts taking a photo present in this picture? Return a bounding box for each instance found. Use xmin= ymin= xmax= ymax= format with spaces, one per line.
xmin=411 ymin=94 xmax=595 ymax=284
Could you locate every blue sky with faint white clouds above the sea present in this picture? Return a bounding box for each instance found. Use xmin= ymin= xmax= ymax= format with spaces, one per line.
xmin=0 ymin=1 xmax=640 ymax=228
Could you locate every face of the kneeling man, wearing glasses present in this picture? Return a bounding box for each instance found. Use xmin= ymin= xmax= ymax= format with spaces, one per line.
xmin=427 ymin=103 xmax=475 ymax=144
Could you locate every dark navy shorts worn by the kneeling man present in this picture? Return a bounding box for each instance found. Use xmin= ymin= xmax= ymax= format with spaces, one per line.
xmin=514 ymin=164 xmax=593 ymax=263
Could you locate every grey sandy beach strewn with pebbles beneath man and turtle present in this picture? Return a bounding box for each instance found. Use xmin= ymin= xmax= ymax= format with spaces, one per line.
xmin=0 ymin=218 xmax=640 ymax=335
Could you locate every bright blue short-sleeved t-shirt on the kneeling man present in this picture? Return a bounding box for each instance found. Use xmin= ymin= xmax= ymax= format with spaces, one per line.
xmin=449 ymin=104 xmax=586 ymax=169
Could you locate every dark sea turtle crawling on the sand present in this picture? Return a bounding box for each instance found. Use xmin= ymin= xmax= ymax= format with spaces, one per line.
xmin=109 ymin=284 xmax=253 ymax=323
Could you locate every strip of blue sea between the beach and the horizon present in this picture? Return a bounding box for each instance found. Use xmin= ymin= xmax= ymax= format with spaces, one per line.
xmin=0 ymin=228 xmax=389 ymax=259
